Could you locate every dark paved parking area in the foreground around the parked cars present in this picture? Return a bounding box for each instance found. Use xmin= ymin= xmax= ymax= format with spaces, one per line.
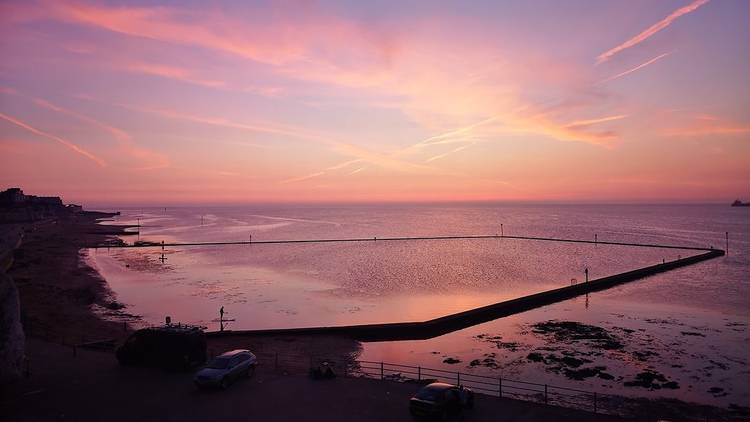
xmin=0 ymin=341 xmax=616 ymax=422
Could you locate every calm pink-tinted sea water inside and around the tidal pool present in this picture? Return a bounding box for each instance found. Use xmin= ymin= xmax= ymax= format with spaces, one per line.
xmin=88 ymin=204 xmax=750 ymax=404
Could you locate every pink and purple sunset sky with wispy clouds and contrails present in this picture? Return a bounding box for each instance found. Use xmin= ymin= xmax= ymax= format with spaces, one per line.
xmin=0 ymin=0 xmax=750 ymax=205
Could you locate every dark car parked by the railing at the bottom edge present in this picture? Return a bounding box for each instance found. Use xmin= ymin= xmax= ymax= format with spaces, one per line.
xmin=409 ymin=382 xmax=474 ymax=420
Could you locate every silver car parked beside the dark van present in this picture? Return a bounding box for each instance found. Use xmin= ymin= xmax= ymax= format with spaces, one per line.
xmin=193 ymin=349 xmax=258 ymax=390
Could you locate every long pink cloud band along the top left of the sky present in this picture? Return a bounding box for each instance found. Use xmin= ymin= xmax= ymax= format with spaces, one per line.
xmin=26 ymin=1 xmax=389 ymax=65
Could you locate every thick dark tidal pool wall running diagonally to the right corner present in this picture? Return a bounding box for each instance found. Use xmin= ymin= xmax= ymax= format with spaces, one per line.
xmin=207 ymin=249 xmax=725 ymax=341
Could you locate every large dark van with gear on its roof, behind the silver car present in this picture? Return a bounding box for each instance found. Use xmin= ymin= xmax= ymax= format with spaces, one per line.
xmin=117 ymin=325 xmax=206 ymax=369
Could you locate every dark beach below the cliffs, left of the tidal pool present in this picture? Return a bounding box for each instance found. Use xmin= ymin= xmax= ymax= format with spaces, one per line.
xmin=8 ymin=211 xmax=135 ymax=344
